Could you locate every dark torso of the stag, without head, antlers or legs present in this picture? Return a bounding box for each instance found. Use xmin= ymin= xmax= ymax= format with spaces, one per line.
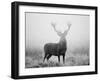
xmin=44 ymin=37 xmax=67 ymax=56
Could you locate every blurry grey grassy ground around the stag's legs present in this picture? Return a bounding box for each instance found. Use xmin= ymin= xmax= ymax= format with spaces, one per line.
xmin=25 ymin=49 xmax=89 ymax=68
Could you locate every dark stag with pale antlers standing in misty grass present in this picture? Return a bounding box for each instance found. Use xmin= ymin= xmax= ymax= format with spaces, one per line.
xmin=43 ymin=23 xmax=71 ymax=63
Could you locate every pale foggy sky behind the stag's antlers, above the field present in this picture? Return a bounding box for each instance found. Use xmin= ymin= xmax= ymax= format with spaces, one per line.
xmin=25 ymin=12 xmax=90 ymax=49
